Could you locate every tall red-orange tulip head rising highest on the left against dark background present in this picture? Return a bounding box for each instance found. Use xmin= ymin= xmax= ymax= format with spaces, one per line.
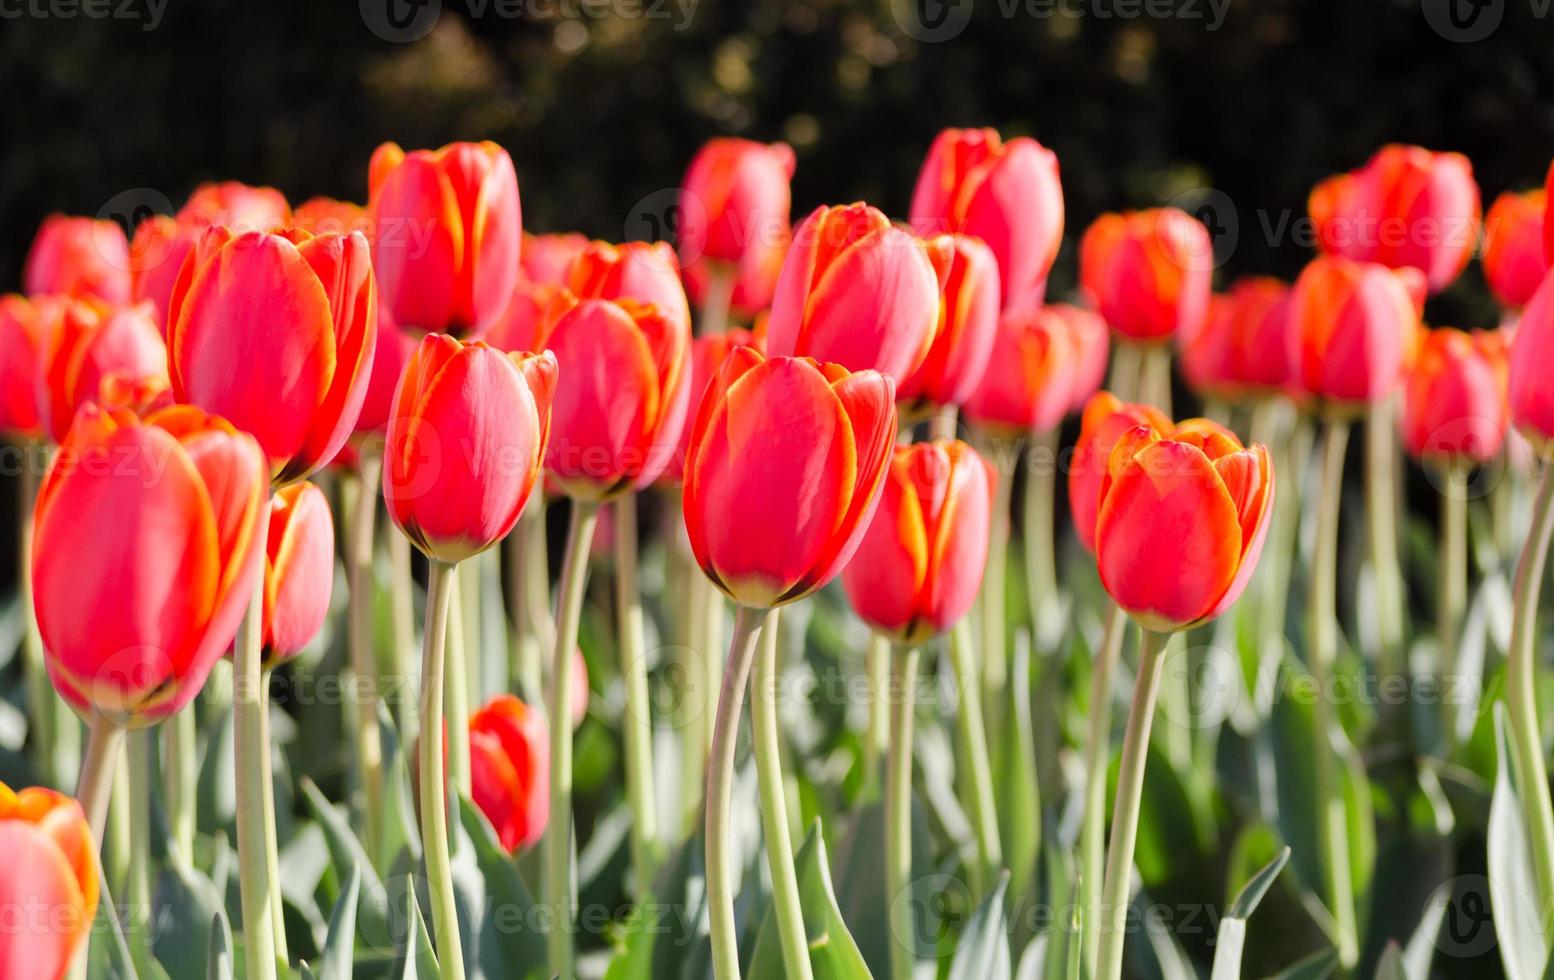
xmin=367 ymin=141 xmax=522 ymax=337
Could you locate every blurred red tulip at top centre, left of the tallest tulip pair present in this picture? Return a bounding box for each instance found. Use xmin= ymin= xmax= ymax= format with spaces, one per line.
xmin=678 ymin=138 xmax=794 ymax=312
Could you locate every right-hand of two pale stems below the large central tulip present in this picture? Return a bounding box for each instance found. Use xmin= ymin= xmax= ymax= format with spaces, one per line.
xmin=751 ymin=609 xmax=814 ymax=980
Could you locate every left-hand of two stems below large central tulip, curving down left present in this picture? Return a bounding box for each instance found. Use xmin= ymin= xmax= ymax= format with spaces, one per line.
xmin=706 ymin=606 xmax=769 ymax=980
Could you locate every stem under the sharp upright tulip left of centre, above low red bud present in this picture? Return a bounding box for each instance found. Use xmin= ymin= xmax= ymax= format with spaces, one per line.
xmin=420 ymin=559 xmax=469 ymax=980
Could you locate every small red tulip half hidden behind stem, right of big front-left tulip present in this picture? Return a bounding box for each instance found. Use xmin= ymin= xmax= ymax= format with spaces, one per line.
xmin=263 ymin=483 xmax=334 ymax=666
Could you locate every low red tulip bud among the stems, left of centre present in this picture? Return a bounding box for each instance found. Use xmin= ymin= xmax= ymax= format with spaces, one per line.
xmin=469 ymin=686 xmax=553 ymax=854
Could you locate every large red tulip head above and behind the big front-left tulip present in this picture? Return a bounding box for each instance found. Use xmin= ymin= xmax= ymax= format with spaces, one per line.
xmin=168 ymin=234 xmax=378 ymax=486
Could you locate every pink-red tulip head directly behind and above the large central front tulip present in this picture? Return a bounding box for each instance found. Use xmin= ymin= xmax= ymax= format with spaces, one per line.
xmin=766 ymin=203 xmax=948 ymax=381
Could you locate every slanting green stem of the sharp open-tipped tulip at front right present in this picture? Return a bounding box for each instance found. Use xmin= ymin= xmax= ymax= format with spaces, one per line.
xmin=1094 ymin=629 xmax=1170 ymax=980
